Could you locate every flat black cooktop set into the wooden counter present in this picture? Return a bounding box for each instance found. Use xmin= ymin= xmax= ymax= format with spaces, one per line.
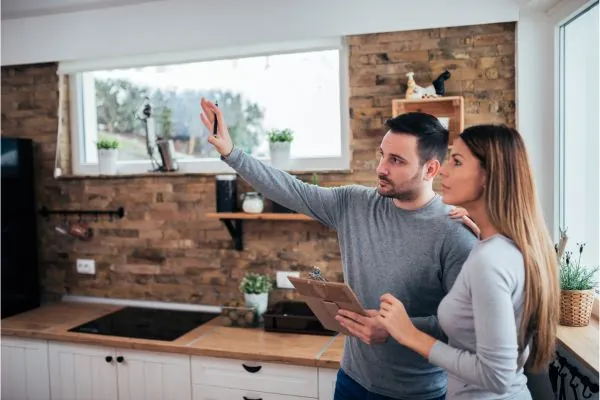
xmin=69 ymin=307 xmax=219 ymax=341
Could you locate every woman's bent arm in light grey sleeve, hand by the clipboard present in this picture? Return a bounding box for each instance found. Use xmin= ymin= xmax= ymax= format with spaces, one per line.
xmin=382 ymin=255 xmax=521 ymax=393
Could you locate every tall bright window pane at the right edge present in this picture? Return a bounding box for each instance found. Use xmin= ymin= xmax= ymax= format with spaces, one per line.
xmin=558 ymin=1 xmax=600 ymax=292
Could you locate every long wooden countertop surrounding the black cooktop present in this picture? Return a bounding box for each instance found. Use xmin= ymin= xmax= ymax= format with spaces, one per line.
xmin=1 ymin=302 xmax=343 ymax=368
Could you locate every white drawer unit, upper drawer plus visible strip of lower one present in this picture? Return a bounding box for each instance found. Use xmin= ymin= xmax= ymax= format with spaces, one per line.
xmin=191 ymin=356 xmax=319 ymax=400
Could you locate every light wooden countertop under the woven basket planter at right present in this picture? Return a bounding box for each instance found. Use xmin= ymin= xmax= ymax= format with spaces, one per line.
xmin=557 ymin=317 xmax=600 ymax=373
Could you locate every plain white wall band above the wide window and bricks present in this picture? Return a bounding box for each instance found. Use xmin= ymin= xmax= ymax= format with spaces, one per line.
xmin=2 ymin=0 xmax=518 ymax=65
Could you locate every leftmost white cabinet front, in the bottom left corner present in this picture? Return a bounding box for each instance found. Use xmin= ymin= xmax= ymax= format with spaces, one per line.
xmin=1 ymin=336 xmax=50 ymax=400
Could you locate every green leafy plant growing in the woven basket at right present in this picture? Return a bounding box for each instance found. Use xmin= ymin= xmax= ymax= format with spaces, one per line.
xmin=555 ymin=238 xmax=599 ymax=290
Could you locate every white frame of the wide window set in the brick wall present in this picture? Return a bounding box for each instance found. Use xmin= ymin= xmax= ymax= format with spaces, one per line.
xmin=68 ymin=37 xmax=351 ymax=176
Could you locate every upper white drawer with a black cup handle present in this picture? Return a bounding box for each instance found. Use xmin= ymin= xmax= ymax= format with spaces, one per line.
xmin=192 ymin=357 xmax=319 ymax=400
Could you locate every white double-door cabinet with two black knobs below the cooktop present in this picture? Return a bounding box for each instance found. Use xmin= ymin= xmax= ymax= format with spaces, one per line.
xmin=48 ymin=342 xmax=191 ymax=400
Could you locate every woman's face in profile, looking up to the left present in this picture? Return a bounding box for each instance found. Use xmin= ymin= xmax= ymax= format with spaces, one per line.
xmin=440 ymin=138 xmax=485 ymax=209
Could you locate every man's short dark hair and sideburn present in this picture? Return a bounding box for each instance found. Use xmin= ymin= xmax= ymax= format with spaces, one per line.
xmin=385 ymin=112 xmax=449 ymax=165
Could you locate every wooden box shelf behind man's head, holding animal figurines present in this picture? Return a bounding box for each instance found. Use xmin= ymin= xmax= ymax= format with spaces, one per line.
xmin=392 ymin=96 xmax=465 ymax=145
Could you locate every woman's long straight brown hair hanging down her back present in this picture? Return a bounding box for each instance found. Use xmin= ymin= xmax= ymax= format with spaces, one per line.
xmin=460 ymin=125 xmax=560 ymax=371
